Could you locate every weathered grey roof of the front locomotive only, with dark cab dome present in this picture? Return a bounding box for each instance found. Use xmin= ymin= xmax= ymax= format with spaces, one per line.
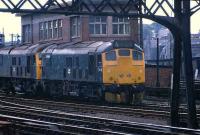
xmin=42 ymin=40 xmax=142 ymax=54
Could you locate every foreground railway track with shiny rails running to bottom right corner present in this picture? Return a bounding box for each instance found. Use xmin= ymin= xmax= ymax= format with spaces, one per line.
xmin=0 ymin=99 xmax=200 ymax=135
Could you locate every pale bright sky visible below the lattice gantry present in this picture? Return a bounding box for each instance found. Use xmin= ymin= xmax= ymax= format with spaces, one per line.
xmin=0 ymin=12 xmax=200 ymax=40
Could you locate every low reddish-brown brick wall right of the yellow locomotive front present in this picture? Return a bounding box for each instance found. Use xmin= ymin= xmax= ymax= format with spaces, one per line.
xmin=145 ymin=65 xmax=173 ymax=88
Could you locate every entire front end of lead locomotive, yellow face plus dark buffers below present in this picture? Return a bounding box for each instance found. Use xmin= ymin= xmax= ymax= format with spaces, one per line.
xmin=102 ymin=48 xmax=145 ymax=103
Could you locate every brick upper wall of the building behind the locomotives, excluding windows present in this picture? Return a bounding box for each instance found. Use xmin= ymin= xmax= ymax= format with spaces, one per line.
xmin=21 ymin=14 xmax=139 ymax=44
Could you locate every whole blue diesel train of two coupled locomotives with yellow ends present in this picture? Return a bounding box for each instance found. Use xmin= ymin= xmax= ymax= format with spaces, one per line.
xmin=0 ymin=40 xmax=145 ymax=103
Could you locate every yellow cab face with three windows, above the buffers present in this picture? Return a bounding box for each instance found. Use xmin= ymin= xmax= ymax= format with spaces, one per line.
xmin=102 ymin=49 xmax=145 ymax=85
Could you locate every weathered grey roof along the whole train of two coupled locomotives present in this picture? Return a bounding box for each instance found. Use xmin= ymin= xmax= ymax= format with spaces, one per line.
xmin=0 ymin=40 xmax=142 ymax=55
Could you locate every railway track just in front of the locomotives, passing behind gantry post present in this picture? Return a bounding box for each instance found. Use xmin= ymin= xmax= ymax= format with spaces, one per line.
xmin=0 ymin=96 xmax=200 ymax=120
